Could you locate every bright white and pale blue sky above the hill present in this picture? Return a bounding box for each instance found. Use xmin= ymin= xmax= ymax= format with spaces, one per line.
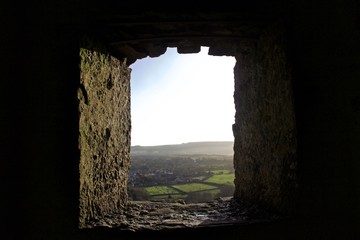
xmin=130 ymin=47 xmax=235 ymax=146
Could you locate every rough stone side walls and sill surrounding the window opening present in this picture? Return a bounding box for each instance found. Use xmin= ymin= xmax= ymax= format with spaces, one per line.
xmin=78 ymin=21 xmax=297 ymax=231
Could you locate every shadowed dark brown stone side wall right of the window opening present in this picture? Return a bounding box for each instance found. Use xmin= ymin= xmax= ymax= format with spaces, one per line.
xmin=233 ymin=23 xmax=296 ymax=214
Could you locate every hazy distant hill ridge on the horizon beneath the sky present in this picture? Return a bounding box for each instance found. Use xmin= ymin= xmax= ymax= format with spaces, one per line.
xmin=131 ymin=141 xmax=234 ymax=155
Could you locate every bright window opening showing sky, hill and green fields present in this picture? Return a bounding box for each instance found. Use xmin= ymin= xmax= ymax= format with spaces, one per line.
xmin=128 ymin=47 xmax=235 ymax=203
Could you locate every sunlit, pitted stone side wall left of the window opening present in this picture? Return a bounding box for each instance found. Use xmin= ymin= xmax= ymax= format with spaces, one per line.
xmin=78 ymin=48 xmax=131 ymax=227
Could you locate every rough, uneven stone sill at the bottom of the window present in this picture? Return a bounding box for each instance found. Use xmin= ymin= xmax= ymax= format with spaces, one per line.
xmin=86 ymin=198 xmax=283 ymax=231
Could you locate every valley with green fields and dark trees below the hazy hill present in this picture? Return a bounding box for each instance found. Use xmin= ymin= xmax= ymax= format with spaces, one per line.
xmin=129 ymin=154 xmax=235 ymax=202
